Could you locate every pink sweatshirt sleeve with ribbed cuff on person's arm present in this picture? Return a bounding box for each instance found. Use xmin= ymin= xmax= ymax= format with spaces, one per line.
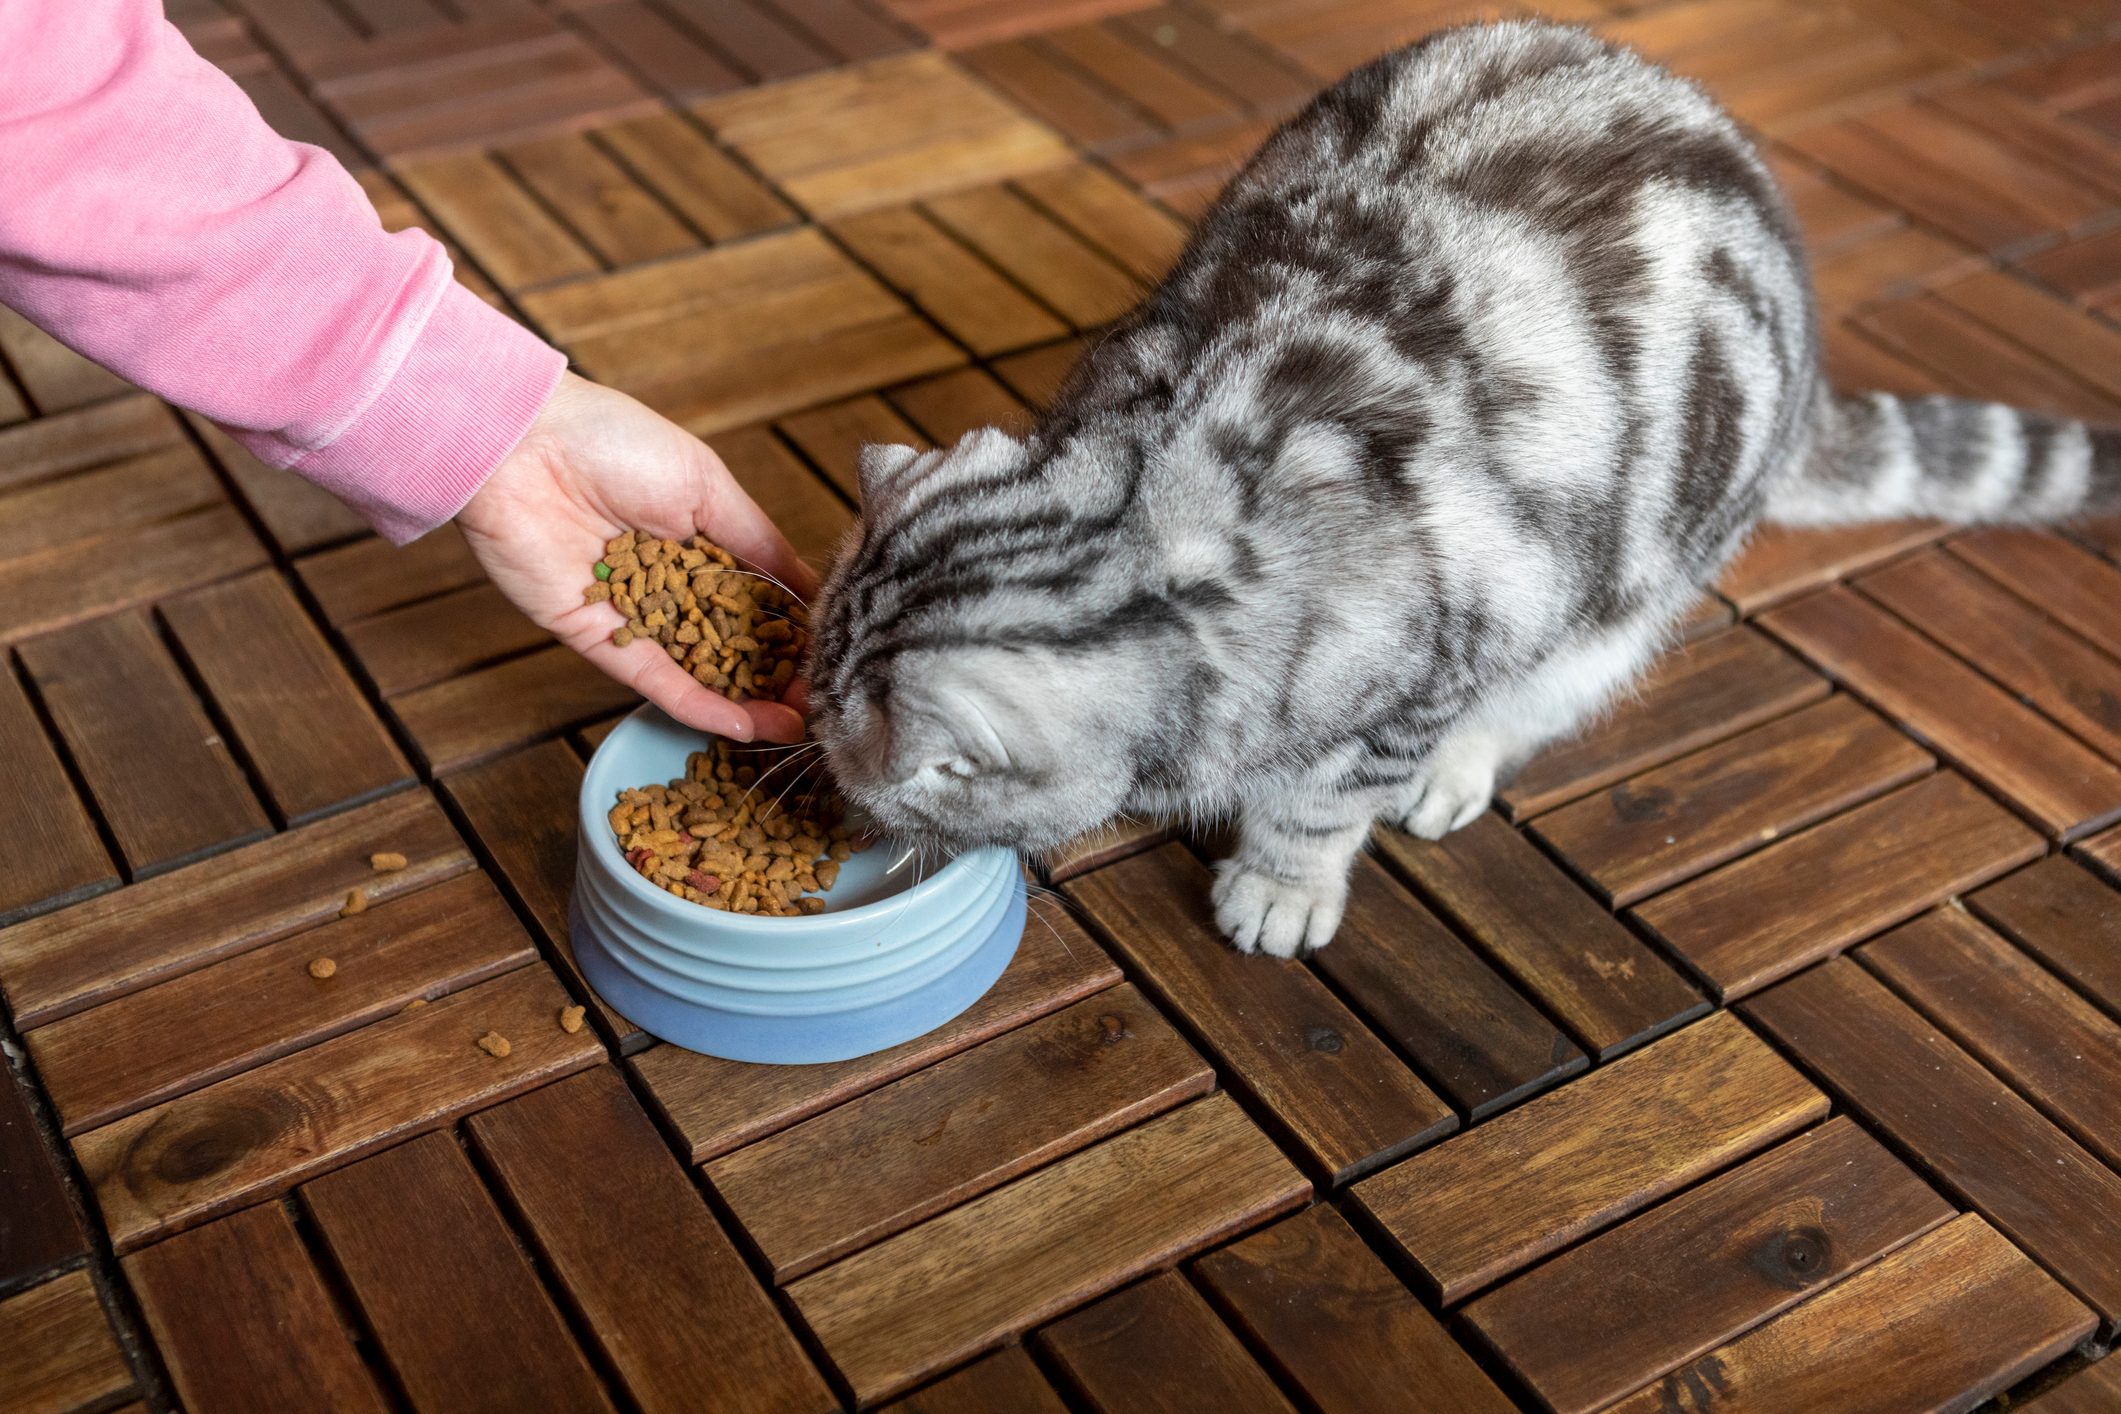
xmin=0 ymin=0 xmax=566 ymax=543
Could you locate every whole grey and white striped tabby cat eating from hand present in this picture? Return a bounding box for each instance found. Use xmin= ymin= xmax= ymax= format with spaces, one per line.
xmin=810 ymin=23 xmax=2121 ymax=956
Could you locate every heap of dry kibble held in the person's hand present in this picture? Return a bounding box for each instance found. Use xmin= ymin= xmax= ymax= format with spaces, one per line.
xmin=583 ymin=530 xmax=810 ymax=702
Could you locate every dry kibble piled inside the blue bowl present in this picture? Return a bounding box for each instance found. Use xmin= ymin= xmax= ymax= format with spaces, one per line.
xmin=609 ymin=740 xmax=867 ymax=918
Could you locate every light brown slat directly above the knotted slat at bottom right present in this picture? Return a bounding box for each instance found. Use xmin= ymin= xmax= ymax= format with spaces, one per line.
xmin=1353 ymin=1011 xmax=1826 ymax=1302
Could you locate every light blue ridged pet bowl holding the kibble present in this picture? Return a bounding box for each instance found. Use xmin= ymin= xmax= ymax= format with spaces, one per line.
xmin=571 ymin=706 xmax=1024 ymax=1064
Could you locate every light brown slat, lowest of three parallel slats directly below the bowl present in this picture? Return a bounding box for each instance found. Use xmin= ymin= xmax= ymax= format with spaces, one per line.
xmin=789 ymin=1094 xmax=1311 ymax=1401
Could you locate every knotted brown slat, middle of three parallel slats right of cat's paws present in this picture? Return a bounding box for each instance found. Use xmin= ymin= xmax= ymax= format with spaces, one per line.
xmin=1531 ymin=695 xmax=1936 ymax=907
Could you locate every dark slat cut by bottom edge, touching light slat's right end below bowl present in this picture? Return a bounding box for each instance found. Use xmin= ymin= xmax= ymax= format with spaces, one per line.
xmin=1194 ymin=1204 xmax=1514 ymax=1414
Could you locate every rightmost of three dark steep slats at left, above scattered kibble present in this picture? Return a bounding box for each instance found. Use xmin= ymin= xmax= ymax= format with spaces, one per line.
xmin=161 ymin=572 xmax=411 ymax=825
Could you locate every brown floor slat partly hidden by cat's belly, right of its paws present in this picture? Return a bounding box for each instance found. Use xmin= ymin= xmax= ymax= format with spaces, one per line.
xmin=1500 ymin=628 xmax=1828 ymax=820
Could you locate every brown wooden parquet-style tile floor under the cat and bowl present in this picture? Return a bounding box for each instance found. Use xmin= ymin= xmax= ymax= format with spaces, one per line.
xmin=0 ymin=0 xmax=2121 ymax=1414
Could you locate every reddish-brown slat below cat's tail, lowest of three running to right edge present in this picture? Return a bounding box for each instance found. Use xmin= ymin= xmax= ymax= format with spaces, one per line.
xmin=1760 ymin=589 xmax=2121 ymax=839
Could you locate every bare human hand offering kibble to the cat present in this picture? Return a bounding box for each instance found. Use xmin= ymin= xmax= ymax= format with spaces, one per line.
xmin=456 ymin=373 xmax=817 ymax=742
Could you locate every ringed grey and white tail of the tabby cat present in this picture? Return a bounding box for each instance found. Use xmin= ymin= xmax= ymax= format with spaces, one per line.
xmin=1767 ymin=392 xmax=2121 ymax=526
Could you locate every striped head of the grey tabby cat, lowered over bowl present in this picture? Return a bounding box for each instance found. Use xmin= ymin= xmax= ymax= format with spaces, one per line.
xmin=810 ymin=428 xmax=1184 ymax=850
